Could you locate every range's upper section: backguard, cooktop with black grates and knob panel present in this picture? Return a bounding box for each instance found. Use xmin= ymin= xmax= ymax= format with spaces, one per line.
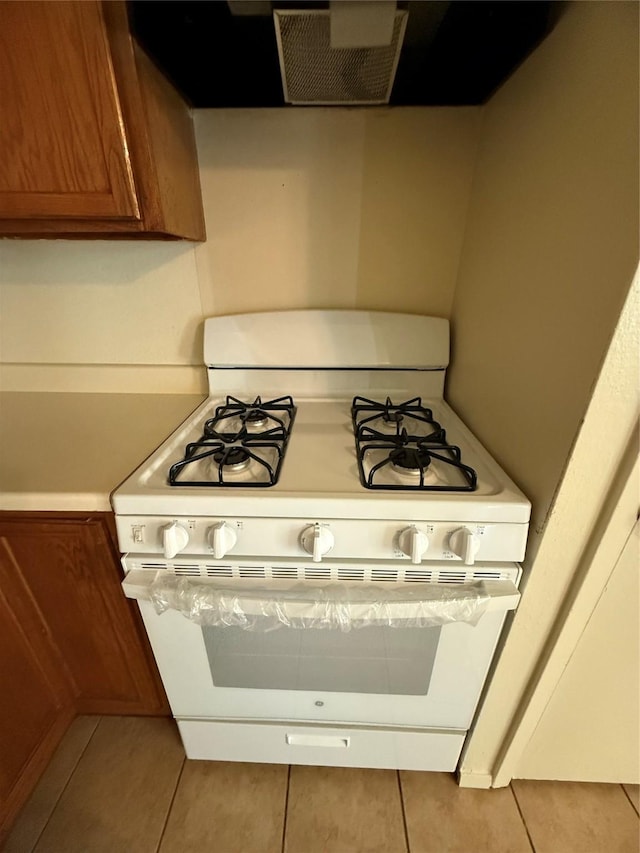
xmin=112 ymin=311 xmax=531 ymax=561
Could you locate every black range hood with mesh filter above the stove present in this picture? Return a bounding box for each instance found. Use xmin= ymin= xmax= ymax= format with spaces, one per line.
xmin=129 ymin=0 xmax=564 ymax=108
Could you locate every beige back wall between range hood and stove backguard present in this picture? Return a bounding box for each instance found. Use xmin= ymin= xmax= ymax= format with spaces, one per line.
xmin=197 ymin=107 xmax=480 ymax=317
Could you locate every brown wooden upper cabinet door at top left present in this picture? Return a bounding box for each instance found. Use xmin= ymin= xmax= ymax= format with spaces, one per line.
xmin=0 ymin=0 xmax=140 ymax=220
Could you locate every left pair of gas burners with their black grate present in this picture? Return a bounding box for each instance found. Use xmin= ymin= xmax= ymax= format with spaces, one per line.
xmin=168 ymin=397 xmax=296 ymax=487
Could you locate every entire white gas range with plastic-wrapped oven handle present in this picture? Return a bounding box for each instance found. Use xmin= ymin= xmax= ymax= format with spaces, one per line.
xmin=112 ymin=311 xmax=530 ymax=770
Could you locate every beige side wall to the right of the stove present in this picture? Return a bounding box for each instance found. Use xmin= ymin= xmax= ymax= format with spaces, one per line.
xmin=447 ymin=2 xmax=638 ymax=558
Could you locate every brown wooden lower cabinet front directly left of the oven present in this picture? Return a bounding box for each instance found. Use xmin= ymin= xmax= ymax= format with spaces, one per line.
xmin=0 ymin=513 xmax=169 ymax=714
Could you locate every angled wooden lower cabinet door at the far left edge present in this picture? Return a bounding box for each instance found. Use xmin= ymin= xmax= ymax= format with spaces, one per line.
xmin=0 ymin=538 xmax=73 ymax=842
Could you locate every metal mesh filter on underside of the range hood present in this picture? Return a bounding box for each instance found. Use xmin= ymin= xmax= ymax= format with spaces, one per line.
xmin=273 ymin=9 xmax=407 ymax=104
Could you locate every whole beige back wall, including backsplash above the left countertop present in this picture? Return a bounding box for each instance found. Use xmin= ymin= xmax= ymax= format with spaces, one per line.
xmin=0 ymin=107 xmax=480 ymax=391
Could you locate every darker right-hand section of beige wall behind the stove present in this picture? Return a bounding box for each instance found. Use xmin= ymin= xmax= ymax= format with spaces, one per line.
xmin=356 ymin=108 xmax=481 ymax=317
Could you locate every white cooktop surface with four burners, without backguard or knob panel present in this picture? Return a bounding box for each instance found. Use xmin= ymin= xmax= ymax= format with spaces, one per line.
xmin=112 ymin=396 xmax=529 ymax=521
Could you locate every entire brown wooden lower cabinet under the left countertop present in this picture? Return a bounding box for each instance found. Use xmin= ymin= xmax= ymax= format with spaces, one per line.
xmin=0 ymin=512 xmax=169 ymax=843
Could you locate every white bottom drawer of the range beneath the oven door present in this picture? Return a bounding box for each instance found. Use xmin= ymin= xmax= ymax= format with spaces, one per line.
xmin=178 ymin=719 xmax=466 ymax=772
